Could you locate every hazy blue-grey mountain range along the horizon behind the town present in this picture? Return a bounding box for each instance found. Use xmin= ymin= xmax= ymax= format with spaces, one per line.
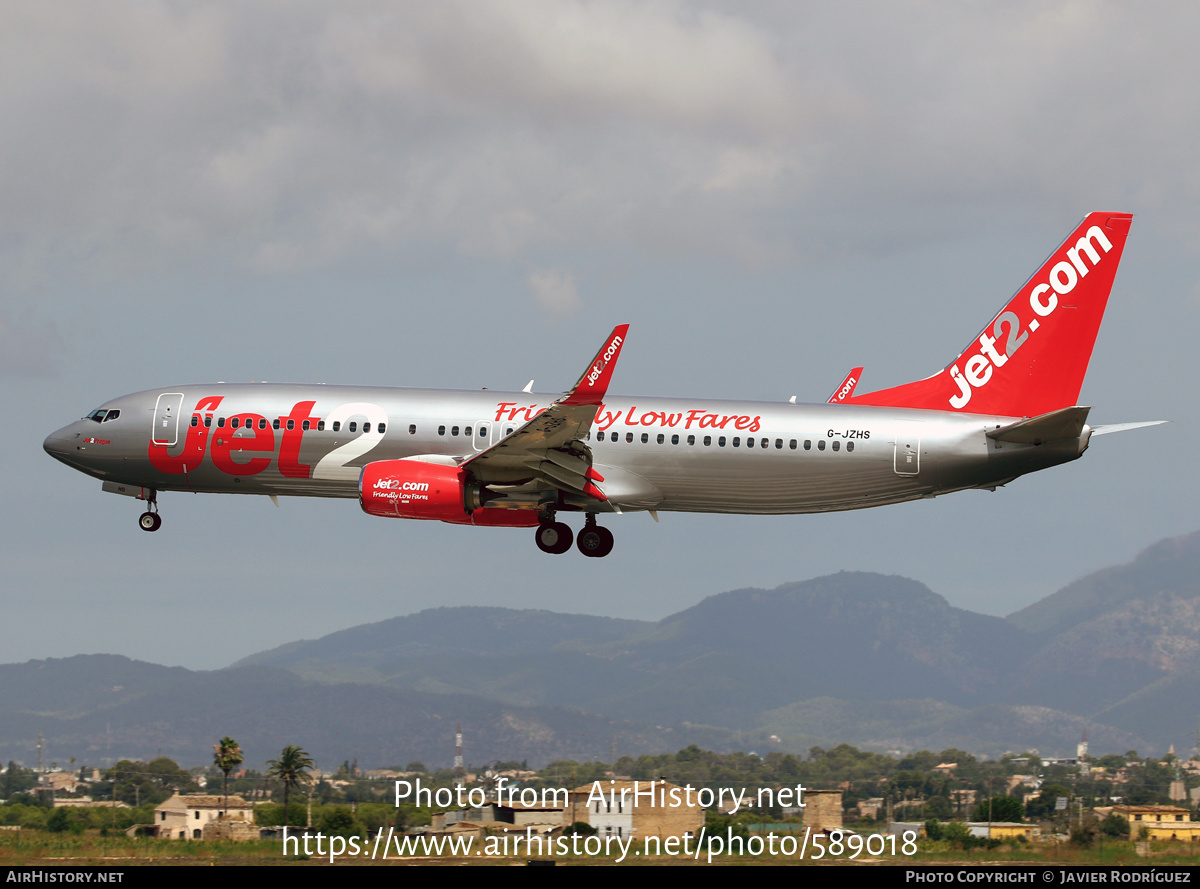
xmin=9 ymin=534 xmax=1200 ymax=767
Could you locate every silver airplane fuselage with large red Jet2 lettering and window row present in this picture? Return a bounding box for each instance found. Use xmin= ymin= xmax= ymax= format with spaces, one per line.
xmin=44 ymin=383 xmax=1091 ymax=515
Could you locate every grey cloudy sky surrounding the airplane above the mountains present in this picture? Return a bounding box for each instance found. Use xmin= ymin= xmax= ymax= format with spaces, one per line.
xmin=0 ymin=0 xmax=1200 ymax=668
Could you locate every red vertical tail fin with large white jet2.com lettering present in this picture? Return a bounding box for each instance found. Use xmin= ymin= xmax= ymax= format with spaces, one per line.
xmin=846 ymin=212 xmax=1133 ymax=416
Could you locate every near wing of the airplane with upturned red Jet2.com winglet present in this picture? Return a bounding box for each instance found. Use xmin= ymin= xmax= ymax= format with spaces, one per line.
xmin=462 ymin=324 xmax=629 ymax=500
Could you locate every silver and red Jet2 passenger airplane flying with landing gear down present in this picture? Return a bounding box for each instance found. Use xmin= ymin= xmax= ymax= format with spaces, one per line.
xmin=44 ymin=212 xmax=1152 ymax=557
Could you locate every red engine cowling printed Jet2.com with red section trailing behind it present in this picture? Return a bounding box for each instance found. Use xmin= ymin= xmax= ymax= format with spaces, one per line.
xmin=359 ymin=459 xmax=539 ymax=528
